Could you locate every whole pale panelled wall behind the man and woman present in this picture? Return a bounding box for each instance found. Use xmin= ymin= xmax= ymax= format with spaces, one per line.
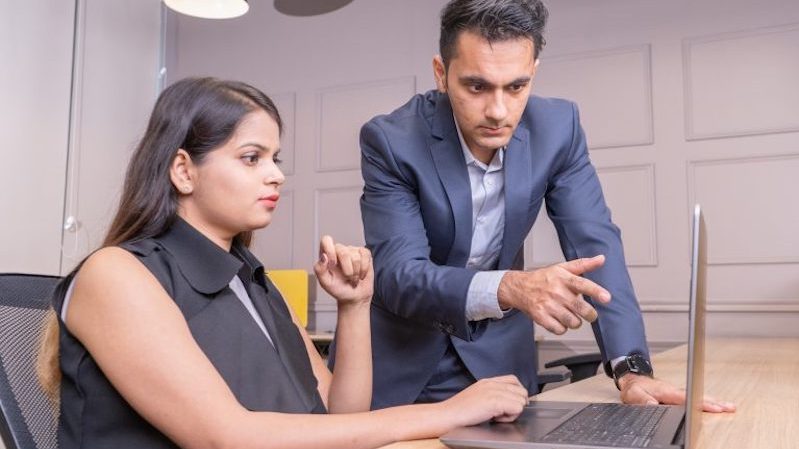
xmin=170 ymin=0 xmax=799 ymax=351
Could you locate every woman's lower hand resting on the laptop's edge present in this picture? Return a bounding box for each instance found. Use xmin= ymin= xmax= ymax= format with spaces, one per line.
xmin=441 ymin=375 xmax=529 ymax=427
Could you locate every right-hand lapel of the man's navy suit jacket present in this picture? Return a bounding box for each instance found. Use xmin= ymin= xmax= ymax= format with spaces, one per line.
xmin=499 ymin=123 xmax=533 ymax=269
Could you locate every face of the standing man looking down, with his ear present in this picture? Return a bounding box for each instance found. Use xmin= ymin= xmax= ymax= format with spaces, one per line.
xmin=433 ymin=31 xmax=537 ymax=163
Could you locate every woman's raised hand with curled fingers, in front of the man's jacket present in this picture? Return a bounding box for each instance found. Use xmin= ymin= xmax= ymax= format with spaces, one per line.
xmin=314 ymin=235 xmax=374 ymax=307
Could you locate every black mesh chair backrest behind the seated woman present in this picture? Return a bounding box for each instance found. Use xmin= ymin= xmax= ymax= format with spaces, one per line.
xmin=0 ymin=273 xmax=60 ymax=449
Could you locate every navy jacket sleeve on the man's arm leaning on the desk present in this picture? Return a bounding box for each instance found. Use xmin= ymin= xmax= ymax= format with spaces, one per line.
xmin=546 ymin=104 xmax=649 ymax=375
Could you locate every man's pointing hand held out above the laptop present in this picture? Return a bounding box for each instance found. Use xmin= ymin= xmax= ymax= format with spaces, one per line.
xmin=497 ymin=255 xmax=610 ymax=335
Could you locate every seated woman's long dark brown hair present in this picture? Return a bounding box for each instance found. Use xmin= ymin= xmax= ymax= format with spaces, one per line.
xmin=38 ymin=78 xmax=283 ymax=400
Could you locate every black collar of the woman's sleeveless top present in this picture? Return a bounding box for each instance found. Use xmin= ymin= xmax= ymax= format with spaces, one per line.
xmin=156 ymin=217 xmax=264 ymax=294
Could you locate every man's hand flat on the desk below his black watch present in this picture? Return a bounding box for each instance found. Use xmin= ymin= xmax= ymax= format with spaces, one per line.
xmin=619 ymin=373 xmax=735 ymax=413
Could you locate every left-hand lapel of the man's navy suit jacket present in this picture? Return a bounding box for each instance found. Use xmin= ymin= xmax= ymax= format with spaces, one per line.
xmin=430 ymin=95 xmax=472 ymax=266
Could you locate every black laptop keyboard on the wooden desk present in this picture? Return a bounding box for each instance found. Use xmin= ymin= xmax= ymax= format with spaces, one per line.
xmin=543 ymin=404 xmax=668 ymax=447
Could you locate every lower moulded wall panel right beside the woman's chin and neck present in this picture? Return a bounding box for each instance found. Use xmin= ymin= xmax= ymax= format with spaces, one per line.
xmin=250 ymin=190 xmax=296 ymax=270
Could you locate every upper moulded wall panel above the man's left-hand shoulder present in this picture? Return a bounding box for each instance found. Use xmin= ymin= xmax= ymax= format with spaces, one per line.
xmin=316 ymin=77 xmax=416 ymax=171
